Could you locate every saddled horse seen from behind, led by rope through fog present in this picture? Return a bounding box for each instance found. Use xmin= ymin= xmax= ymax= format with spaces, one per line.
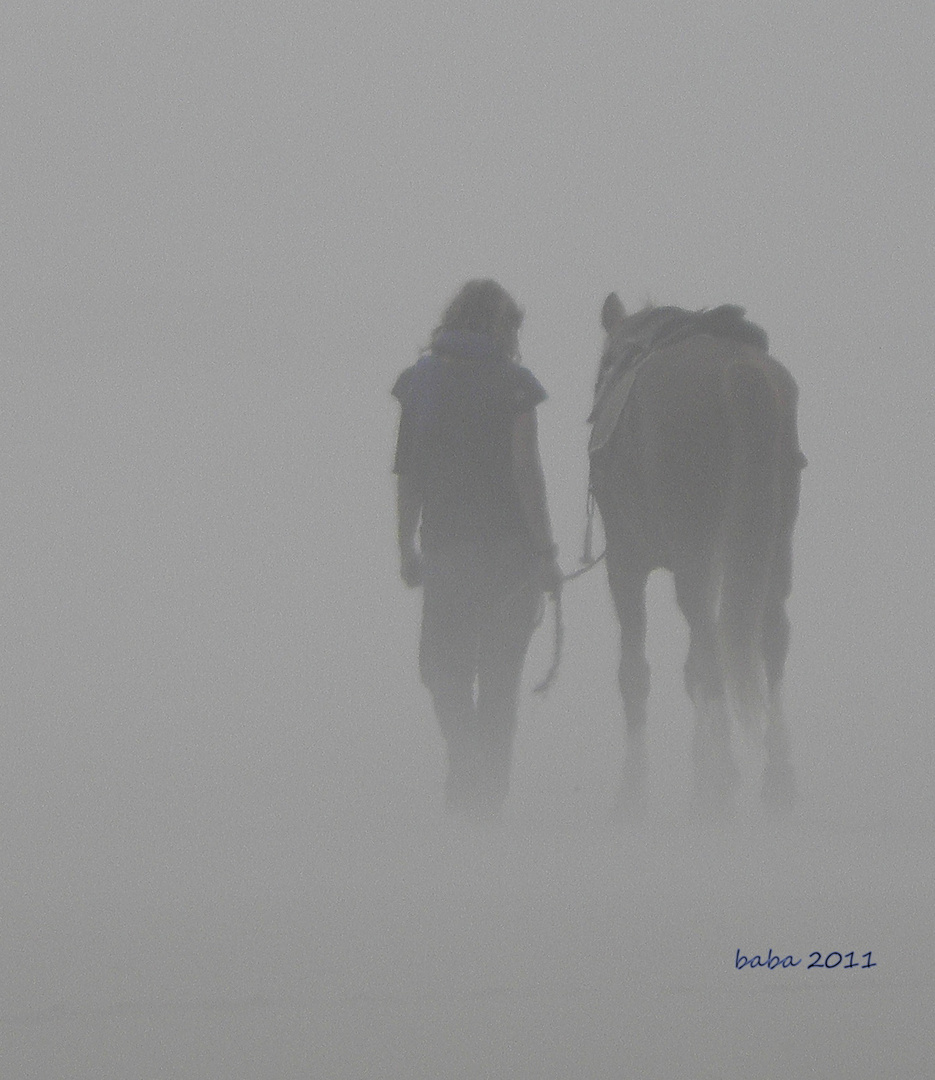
xmin=588 ymin=293 xmax=807 ymax=816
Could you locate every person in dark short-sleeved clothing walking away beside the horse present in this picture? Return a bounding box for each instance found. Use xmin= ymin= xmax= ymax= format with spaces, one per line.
xmin=392 ymin=280 xmax=561 ymax=819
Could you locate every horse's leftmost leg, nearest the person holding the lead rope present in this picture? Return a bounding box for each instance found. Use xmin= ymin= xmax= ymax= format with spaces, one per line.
xmin=607 ymin=552 xmax=649 ymax=818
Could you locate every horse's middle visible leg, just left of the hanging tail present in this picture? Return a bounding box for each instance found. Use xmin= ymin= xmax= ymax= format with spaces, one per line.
xmin=675 ymin=565 xmax=740 ymax=816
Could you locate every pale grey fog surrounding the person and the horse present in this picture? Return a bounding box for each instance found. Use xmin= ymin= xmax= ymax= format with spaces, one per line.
xmin=0 ymin=0 xmax=935 ymax=1080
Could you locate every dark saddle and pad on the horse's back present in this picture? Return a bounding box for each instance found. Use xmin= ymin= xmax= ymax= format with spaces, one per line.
xmin=587 ymin=303 xmax=769 ymax=456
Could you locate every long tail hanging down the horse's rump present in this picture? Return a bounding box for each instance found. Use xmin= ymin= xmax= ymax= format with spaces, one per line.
xmin=719 ymin=362 xmax=781 ymax=726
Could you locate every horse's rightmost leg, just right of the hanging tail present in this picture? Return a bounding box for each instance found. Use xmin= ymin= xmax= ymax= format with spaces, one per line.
xmin=762 ymin=536 xmax=796 ymax=810
